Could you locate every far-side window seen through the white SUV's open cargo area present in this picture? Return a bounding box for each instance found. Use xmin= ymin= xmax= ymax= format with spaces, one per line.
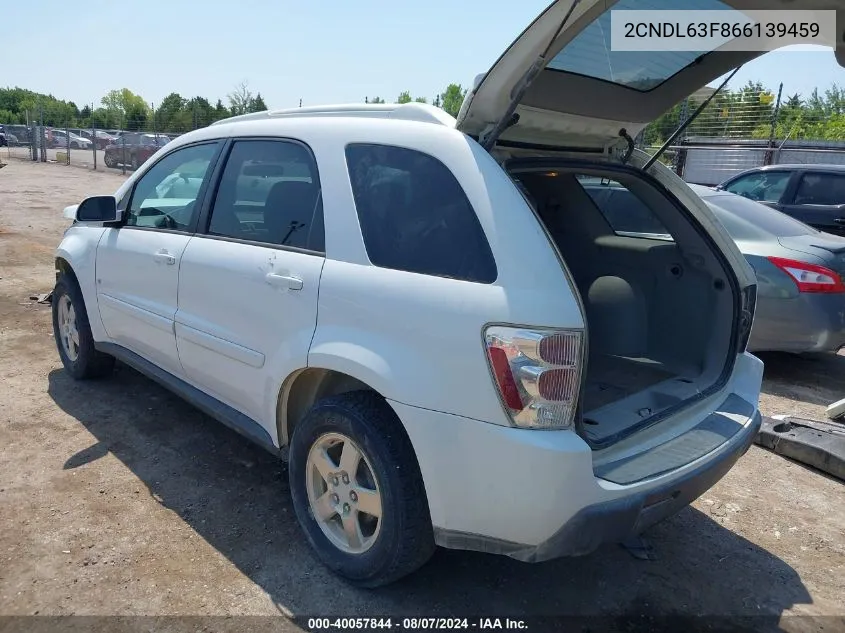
xmin=578 ymin=176 xmax=671 ymax=238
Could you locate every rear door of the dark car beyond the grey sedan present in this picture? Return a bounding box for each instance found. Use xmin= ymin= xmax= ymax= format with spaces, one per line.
xmin=781 ymin=170 xmax=845 ymax=235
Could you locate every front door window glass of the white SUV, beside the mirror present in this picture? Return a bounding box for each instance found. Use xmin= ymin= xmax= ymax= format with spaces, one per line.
xmin=124 ymin=143 xmax=217 ymax=231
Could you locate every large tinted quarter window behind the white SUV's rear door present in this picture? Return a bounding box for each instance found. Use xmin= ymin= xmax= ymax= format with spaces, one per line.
xmin=346 ymin=143 xmax=497 ymax=283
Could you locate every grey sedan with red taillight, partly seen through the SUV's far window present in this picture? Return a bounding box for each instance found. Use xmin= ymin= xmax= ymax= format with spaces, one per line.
xmin=585 ymin=179 xmax=845 ymax=352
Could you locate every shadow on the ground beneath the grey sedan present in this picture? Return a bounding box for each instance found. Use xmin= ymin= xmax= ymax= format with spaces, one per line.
xmin=758 ymin=352 xmax=845 ymax=407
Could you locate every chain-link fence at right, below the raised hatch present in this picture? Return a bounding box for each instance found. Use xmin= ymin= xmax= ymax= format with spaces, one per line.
xmin=638 ymin=82 xmax=845 ymax=185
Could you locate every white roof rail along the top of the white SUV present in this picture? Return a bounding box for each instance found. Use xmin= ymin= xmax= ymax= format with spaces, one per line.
xmin=211 ymin=103 xmax=455 ymax=127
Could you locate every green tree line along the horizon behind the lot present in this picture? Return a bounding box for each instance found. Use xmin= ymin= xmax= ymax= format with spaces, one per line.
xmin=0 ymin=81 xmax=845 ymax=141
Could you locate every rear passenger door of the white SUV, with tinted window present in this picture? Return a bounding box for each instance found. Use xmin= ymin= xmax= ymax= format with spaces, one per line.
xmin=176 ymin=139 xmax=324 ymax=428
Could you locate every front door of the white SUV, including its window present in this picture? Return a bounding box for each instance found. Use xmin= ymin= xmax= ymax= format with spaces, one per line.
xmin=96 ymin=142 xmax=220 ymax=376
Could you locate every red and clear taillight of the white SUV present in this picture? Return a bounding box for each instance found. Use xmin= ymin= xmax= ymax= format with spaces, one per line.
xmin=484 ymin=325 xmax=584 ymax=429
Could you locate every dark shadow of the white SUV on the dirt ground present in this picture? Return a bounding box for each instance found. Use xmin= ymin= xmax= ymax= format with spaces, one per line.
xmin=49 ymin=367 xmax=811 ymax=617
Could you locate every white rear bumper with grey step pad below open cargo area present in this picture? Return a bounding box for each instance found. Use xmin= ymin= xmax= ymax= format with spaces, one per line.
xmin=389 ymin=354 xmax=763 ymax=562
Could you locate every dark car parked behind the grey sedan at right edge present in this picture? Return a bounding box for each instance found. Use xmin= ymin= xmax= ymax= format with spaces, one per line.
xmin=716 ymin=165 xmax=845 ymax=235
